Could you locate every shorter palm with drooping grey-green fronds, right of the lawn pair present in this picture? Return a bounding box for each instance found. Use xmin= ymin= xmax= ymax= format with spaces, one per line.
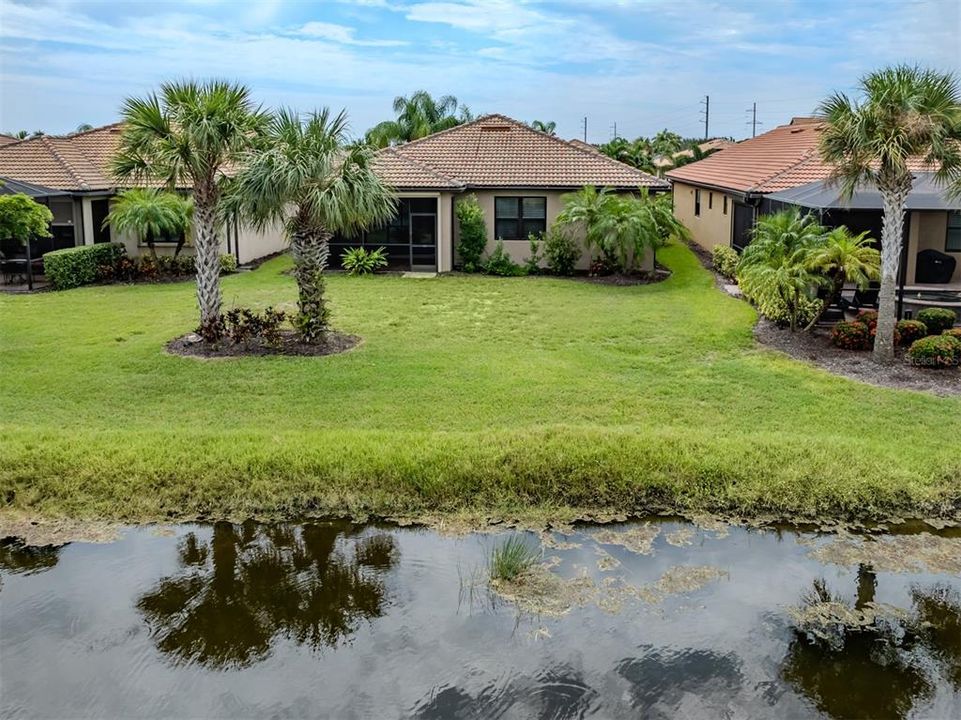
xmin=230 ymin=108 xmax=395 ymax=342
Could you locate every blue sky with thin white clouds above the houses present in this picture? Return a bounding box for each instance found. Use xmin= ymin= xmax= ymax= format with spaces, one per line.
xmin=0 ymin=0 xmax=961 ymax=142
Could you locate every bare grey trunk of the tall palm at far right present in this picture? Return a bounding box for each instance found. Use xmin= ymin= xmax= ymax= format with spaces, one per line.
xmin=874 ymin=186 xmax=911 ymax=364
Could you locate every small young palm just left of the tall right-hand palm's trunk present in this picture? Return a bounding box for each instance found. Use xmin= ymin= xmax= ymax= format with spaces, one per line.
xmin=807 ymin=225 xmax=881 ymax=325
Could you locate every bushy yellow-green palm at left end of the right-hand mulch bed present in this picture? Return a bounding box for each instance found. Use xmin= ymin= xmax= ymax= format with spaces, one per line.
xmin=737 ymin=209 xmax=824 ymax=332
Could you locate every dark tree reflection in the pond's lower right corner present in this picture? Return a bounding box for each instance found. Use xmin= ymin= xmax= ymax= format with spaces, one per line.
xmin=781 ymin=565 xmax=961 ymax=718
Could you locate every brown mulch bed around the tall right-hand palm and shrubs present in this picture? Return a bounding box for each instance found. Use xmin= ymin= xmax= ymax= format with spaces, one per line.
xmin=754 ymin=318 xmax=961 ymax=395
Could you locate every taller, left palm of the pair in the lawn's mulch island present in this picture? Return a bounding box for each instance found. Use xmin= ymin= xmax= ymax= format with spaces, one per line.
xmin=112 ymin=80 xmax=267 ymax=340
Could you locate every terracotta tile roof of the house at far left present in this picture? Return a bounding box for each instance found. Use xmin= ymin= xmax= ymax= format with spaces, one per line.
xmin=0 ymin=124 xmax=120 ymax=191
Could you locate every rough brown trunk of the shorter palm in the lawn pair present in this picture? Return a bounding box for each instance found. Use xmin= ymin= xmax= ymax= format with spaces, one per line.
xmin=290 ymin=231 xmax=330 ymax=343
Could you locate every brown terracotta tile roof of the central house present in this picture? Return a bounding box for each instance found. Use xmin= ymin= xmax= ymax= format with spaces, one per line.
xmin=381 ymin=114 xmax=668 ymax=189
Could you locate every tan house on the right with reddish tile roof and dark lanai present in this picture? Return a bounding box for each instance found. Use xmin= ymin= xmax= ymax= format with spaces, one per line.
xmin=667 ymin=118 xmax=961 ymax=310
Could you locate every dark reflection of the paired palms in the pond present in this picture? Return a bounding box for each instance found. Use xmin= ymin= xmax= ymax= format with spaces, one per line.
xmin=137 ymin=522 xmax=396 ymax=668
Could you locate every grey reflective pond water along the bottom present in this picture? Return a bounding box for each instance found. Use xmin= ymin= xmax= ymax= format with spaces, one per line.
xmin=0 ymin=519 xmax=961 ymax=718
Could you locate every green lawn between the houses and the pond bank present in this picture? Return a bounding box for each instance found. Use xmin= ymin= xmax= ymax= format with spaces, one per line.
xmin=0 ymin=245 xmax=961 ymax=520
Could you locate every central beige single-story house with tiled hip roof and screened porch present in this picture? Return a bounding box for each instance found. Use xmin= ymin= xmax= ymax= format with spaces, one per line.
xmin=344 ymin=114 xmax=670 ymax=272
